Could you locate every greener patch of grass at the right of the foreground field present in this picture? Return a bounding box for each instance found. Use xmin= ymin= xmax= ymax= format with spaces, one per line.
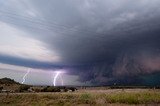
xmin=106 ymin=92 xmax=160 ymax=104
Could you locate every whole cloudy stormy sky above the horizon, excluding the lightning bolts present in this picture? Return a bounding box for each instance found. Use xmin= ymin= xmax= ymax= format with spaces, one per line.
xmin=0 ymin=0 xmax=160 ymax=86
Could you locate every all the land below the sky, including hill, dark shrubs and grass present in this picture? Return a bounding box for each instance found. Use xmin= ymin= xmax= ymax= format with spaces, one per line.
xmin=0 ymin=78 xmax=160 ymax=106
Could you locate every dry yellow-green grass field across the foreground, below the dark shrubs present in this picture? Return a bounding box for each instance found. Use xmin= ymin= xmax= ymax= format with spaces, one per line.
xmin=0 ymin=89 xmax=160 ymax=106
